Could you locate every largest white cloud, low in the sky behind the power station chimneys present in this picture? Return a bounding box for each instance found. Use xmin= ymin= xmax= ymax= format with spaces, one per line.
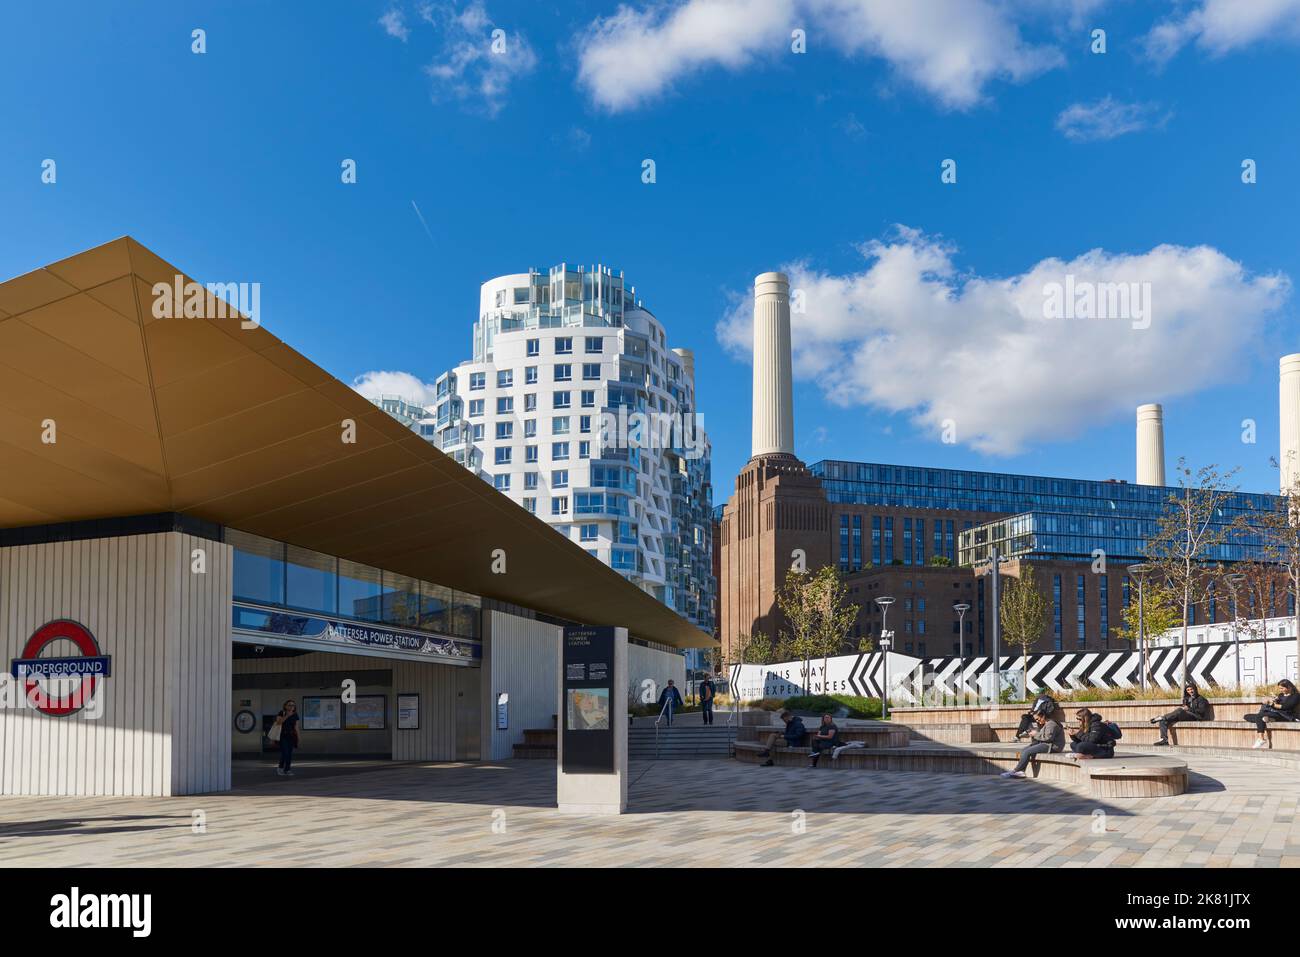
xmin=718 ymin=226 xmax=1291 ymax=454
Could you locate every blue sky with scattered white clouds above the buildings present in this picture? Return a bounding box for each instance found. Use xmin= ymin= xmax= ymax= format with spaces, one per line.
xmin=0 ymin=0 xmax=1300 ymax=502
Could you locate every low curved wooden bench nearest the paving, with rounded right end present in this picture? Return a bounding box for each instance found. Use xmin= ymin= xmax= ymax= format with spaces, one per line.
xmin=736 ymin=741 xmax=1187 ymax=798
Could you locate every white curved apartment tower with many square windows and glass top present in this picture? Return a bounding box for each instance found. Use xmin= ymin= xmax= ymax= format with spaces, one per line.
xmin=431 ymin=264 xmax=715 ymax=632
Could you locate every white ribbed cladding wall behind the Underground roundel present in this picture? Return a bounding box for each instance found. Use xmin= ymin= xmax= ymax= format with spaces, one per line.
xmin=0 ymin=532 xmax=231 ymax=796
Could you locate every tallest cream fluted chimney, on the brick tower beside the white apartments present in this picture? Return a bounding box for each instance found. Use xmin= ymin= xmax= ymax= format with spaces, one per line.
xmin=750 ymin=273 xmax=794 ymax=459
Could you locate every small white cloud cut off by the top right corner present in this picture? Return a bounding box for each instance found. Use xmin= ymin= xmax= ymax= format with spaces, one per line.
xmin=1145 ymin=0 xmax=1300 ymax=62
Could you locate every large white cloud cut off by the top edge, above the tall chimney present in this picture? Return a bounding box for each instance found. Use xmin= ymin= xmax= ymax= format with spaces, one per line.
xmin=579 ymin=0 xmax=1071 ymax=111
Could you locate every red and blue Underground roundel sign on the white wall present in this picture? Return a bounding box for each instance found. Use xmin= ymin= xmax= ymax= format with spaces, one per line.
xmin=10 ymin=618 xmax=112 ymax=718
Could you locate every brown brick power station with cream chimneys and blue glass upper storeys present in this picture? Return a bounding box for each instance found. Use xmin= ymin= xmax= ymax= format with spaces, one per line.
xmin=718 ymin=273 xmax=1300 ymax=658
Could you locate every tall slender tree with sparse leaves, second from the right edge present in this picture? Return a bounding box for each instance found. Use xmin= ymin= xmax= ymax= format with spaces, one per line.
xmin=1147 ymin=459 xmax=1240 ymax=684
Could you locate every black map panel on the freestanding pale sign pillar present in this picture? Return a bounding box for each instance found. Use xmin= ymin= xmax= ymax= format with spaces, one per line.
xmin=560 ymin=625 xmax=621 ymax=774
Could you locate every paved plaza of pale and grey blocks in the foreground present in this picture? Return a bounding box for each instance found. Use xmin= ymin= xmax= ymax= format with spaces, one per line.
xmin=0 ymin=758 xmax=1300 ymax=867
